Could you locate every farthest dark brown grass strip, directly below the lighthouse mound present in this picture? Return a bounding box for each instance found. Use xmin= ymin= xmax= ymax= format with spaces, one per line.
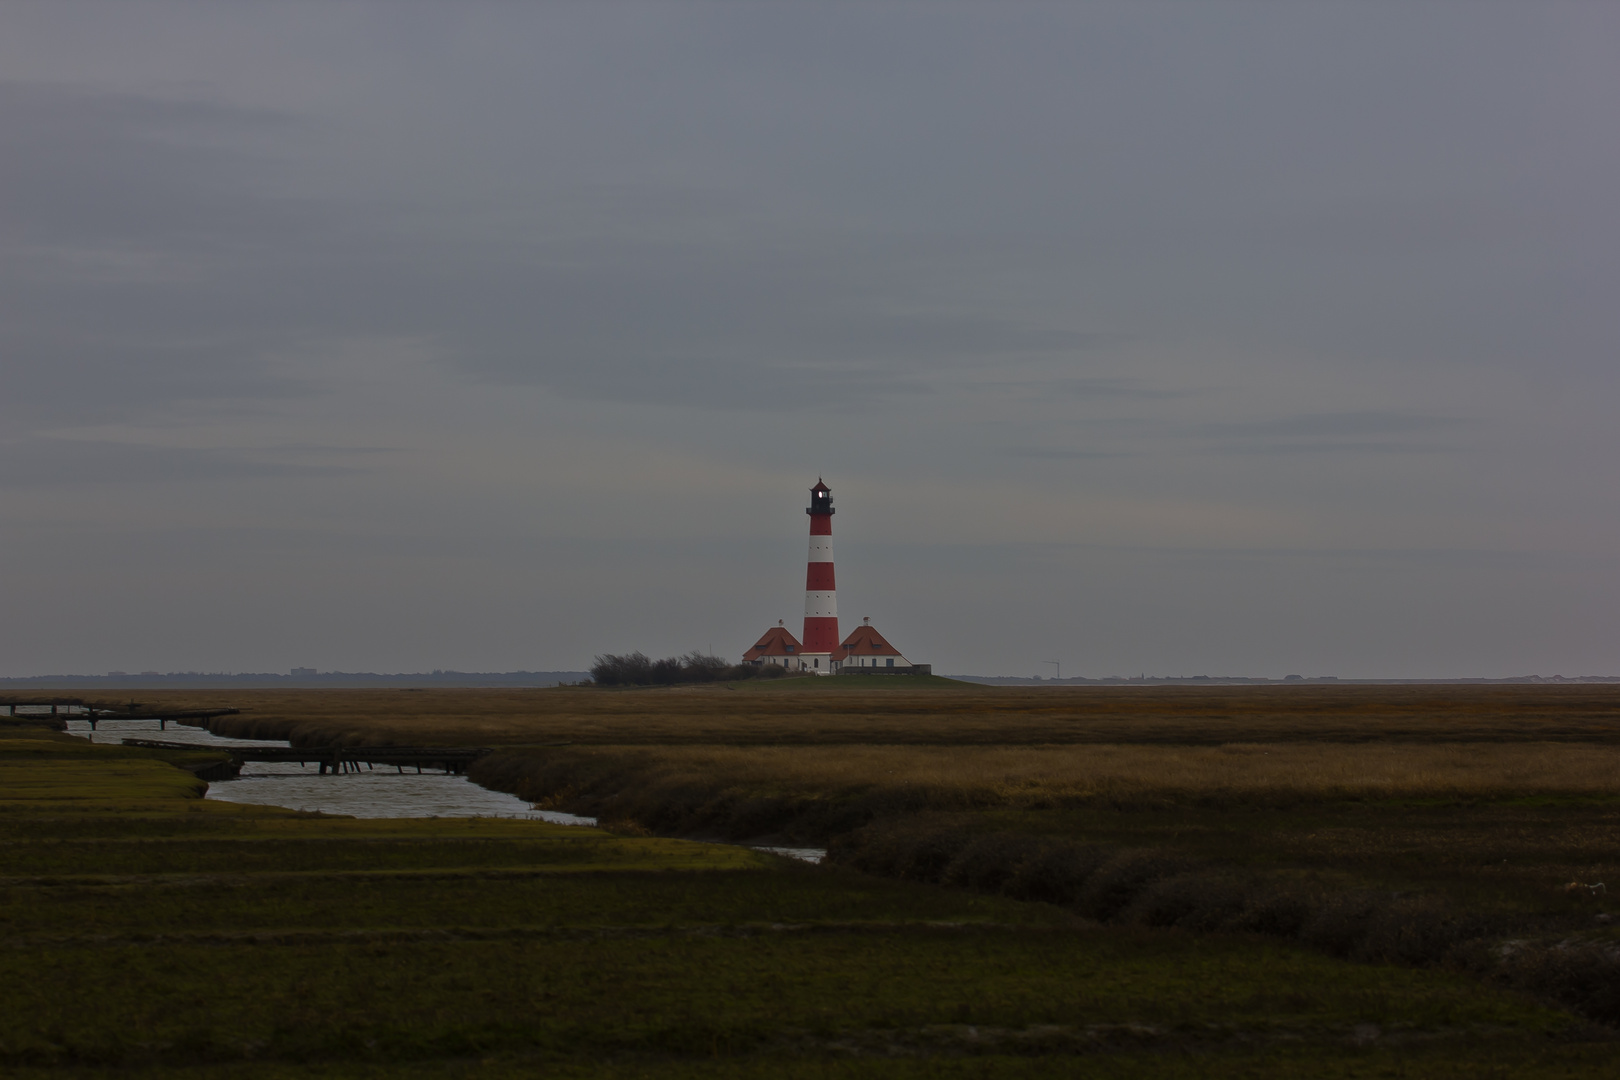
xmin=94 ymin=677 xmax=1620 ymax=745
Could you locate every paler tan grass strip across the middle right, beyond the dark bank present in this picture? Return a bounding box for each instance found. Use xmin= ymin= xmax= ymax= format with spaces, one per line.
xmin=495 ymin=742 xmax=1620 ymax=808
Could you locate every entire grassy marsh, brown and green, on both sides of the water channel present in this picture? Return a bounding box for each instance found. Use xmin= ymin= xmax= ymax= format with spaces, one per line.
xmin=9 ymin=693 xmax=1620 ymax=1078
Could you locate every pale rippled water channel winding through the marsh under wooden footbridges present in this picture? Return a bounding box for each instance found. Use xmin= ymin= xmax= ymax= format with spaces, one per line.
xmin=66 ymin=716 xmax=826 ymax=863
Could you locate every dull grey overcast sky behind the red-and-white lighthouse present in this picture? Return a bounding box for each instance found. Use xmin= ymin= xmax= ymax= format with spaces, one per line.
xmin=0 ymin=0 xmax=1620 ymax=677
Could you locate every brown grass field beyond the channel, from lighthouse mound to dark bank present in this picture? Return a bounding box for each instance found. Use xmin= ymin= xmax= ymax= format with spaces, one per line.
xmin=101 ymin=678 xmax=1620 ymax=918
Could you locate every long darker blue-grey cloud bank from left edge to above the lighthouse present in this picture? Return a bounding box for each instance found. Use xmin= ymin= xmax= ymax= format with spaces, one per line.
xmin=0 ymin=74 xmax=1092 ymax=415
